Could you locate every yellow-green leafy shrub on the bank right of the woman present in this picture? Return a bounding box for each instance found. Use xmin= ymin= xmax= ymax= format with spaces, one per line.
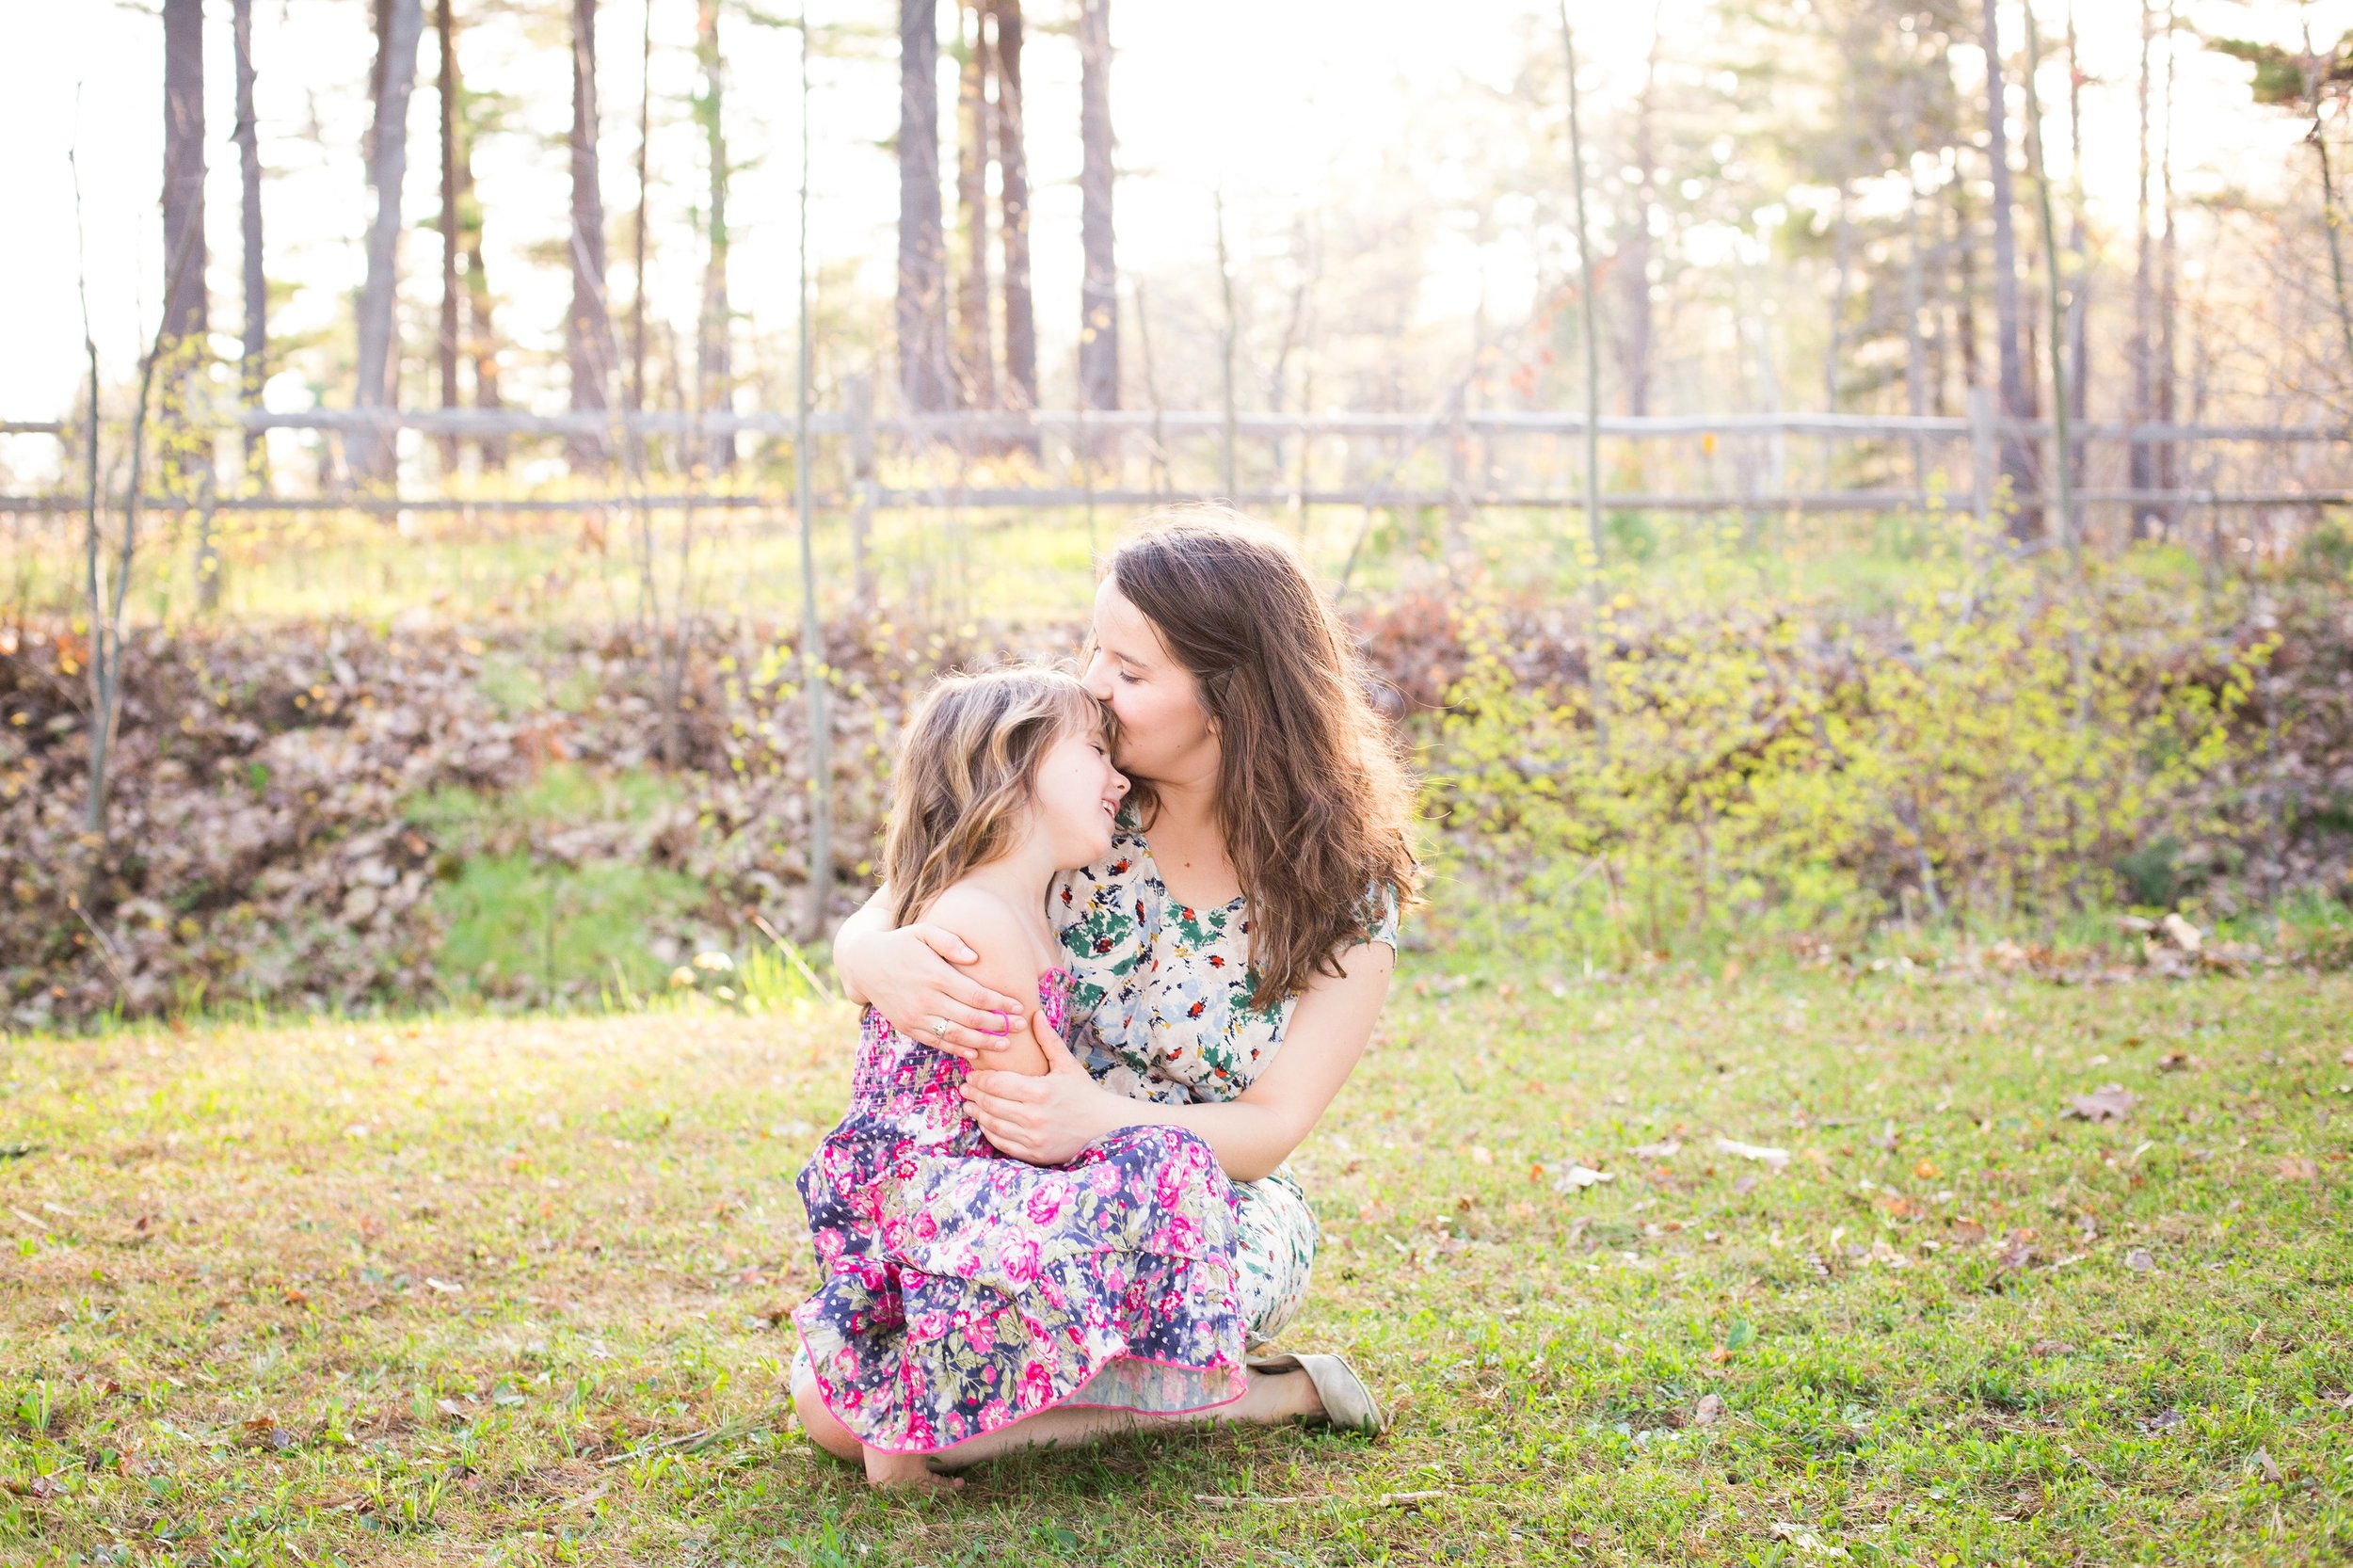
xmin=1431 ymin=555 xmax=2271 ymax=963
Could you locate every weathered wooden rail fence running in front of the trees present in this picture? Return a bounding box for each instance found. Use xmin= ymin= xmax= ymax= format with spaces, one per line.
xmin=0 ymin=389 xmax=2353 ymax=520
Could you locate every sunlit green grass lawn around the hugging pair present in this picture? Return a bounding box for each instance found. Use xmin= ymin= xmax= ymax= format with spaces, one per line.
xmin=0 ymin=966 xmax=2353 ymax=1568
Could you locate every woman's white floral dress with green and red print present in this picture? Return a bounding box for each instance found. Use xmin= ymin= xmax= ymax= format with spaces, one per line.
xmin=1052 ymin=812 xmax=1398 ymax=1344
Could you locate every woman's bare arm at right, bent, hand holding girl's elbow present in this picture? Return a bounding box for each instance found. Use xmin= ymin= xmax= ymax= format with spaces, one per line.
xmin=965 ymin=942 xmax=1398 ymax=1182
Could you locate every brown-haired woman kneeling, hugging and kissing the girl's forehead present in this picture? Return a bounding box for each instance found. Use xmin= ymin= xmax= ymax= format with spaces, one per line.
xmin=793 ymin=511 xmax=1415 ymax=1462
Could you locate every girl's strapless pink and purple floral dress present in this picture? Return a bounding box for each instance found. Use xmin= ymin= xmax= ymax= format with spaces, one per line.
xmin=793 ymin=970 xmax=1245 ymax=1452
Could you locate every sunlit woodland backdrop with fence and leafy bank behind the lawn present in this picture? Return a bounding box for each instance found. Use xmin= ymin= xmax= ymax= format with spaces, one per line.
xmin=0 ymin=0 xmax=2353 ymax=1027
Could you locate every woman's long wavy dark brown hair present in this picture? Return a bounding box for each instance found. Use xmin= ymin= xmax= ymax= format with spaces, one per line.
xmin=1111 ymin=506 xmax=1417 ymax=1008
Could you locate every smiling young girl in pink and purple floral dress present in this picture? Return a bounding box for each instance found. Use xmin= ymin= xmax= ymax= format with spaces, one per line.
xmin=793 ymin=668 xmax=1247 ymax=1485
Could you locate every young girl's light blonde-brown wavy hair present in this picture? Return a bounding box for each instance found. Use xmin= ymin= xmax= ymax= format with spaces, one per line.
xmin=883 ymin=666 xmax=1111 ymax=925
